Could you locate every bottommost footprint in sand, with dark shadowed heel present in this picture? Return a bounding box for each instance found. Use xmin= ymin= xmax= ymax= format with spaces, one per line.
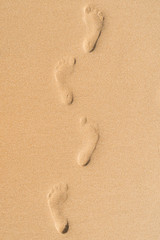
xmin=48 ymin=183 xmax=69 ymax=233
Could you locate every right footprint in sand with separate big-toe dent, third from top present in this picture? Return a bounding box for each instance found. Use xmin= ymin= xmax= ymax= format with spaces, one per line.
xmin=77 ymin=117 xmax=99 ymax=166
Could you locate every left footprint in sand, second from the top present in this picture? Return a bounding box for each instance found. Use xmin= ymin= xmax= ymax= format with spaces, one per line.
xmin=54 ymin=57 xmax=76 ymax=105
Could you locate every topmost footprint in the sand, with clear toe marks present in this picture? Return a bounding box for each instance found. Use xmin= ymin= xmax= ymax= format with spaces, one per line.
xmin=83 ymin=5 xmax=104 ymax=52
